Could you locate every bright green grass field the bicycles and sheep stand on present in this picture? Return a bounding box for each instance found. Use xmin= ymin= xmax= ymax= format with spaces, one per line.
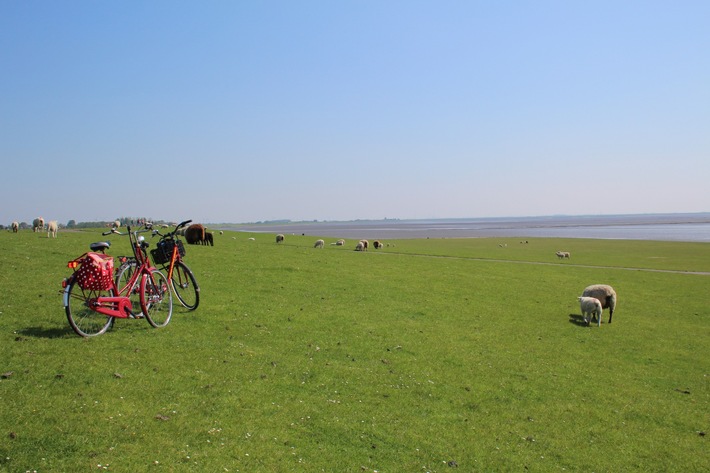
xmin=0 ymin=230 xmax=710 ymax=472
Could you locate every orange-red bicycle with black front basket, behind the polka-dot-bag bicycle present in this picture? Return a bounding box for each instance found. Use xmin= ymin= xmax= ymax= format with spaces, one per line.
xmin=116 ymin=220 xmax=200 ymax=310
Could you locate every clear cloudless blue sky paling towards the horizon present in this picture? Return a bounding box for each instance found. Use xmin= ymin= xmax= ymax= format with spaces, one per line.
xmin=0 ymin=0 xmax=710 ymax=225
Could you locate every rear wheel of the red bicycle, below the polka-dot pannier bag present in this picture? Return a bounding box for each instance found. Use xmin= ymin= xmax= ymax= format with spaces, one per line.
xmin=64 ymin=280 xmax=114 ymax=337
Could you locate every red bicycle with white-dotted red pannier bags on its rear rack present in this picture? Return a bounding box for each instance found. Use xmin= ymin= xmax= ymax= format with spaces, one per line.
xmin=62 ymin=226 xmax=173 ymax=337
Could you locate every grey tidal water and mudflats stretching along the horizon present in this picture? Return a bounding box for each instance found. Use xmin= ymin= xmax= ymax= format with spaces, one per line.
xmin=222 ymin=213 xmax=710 ymax=242
